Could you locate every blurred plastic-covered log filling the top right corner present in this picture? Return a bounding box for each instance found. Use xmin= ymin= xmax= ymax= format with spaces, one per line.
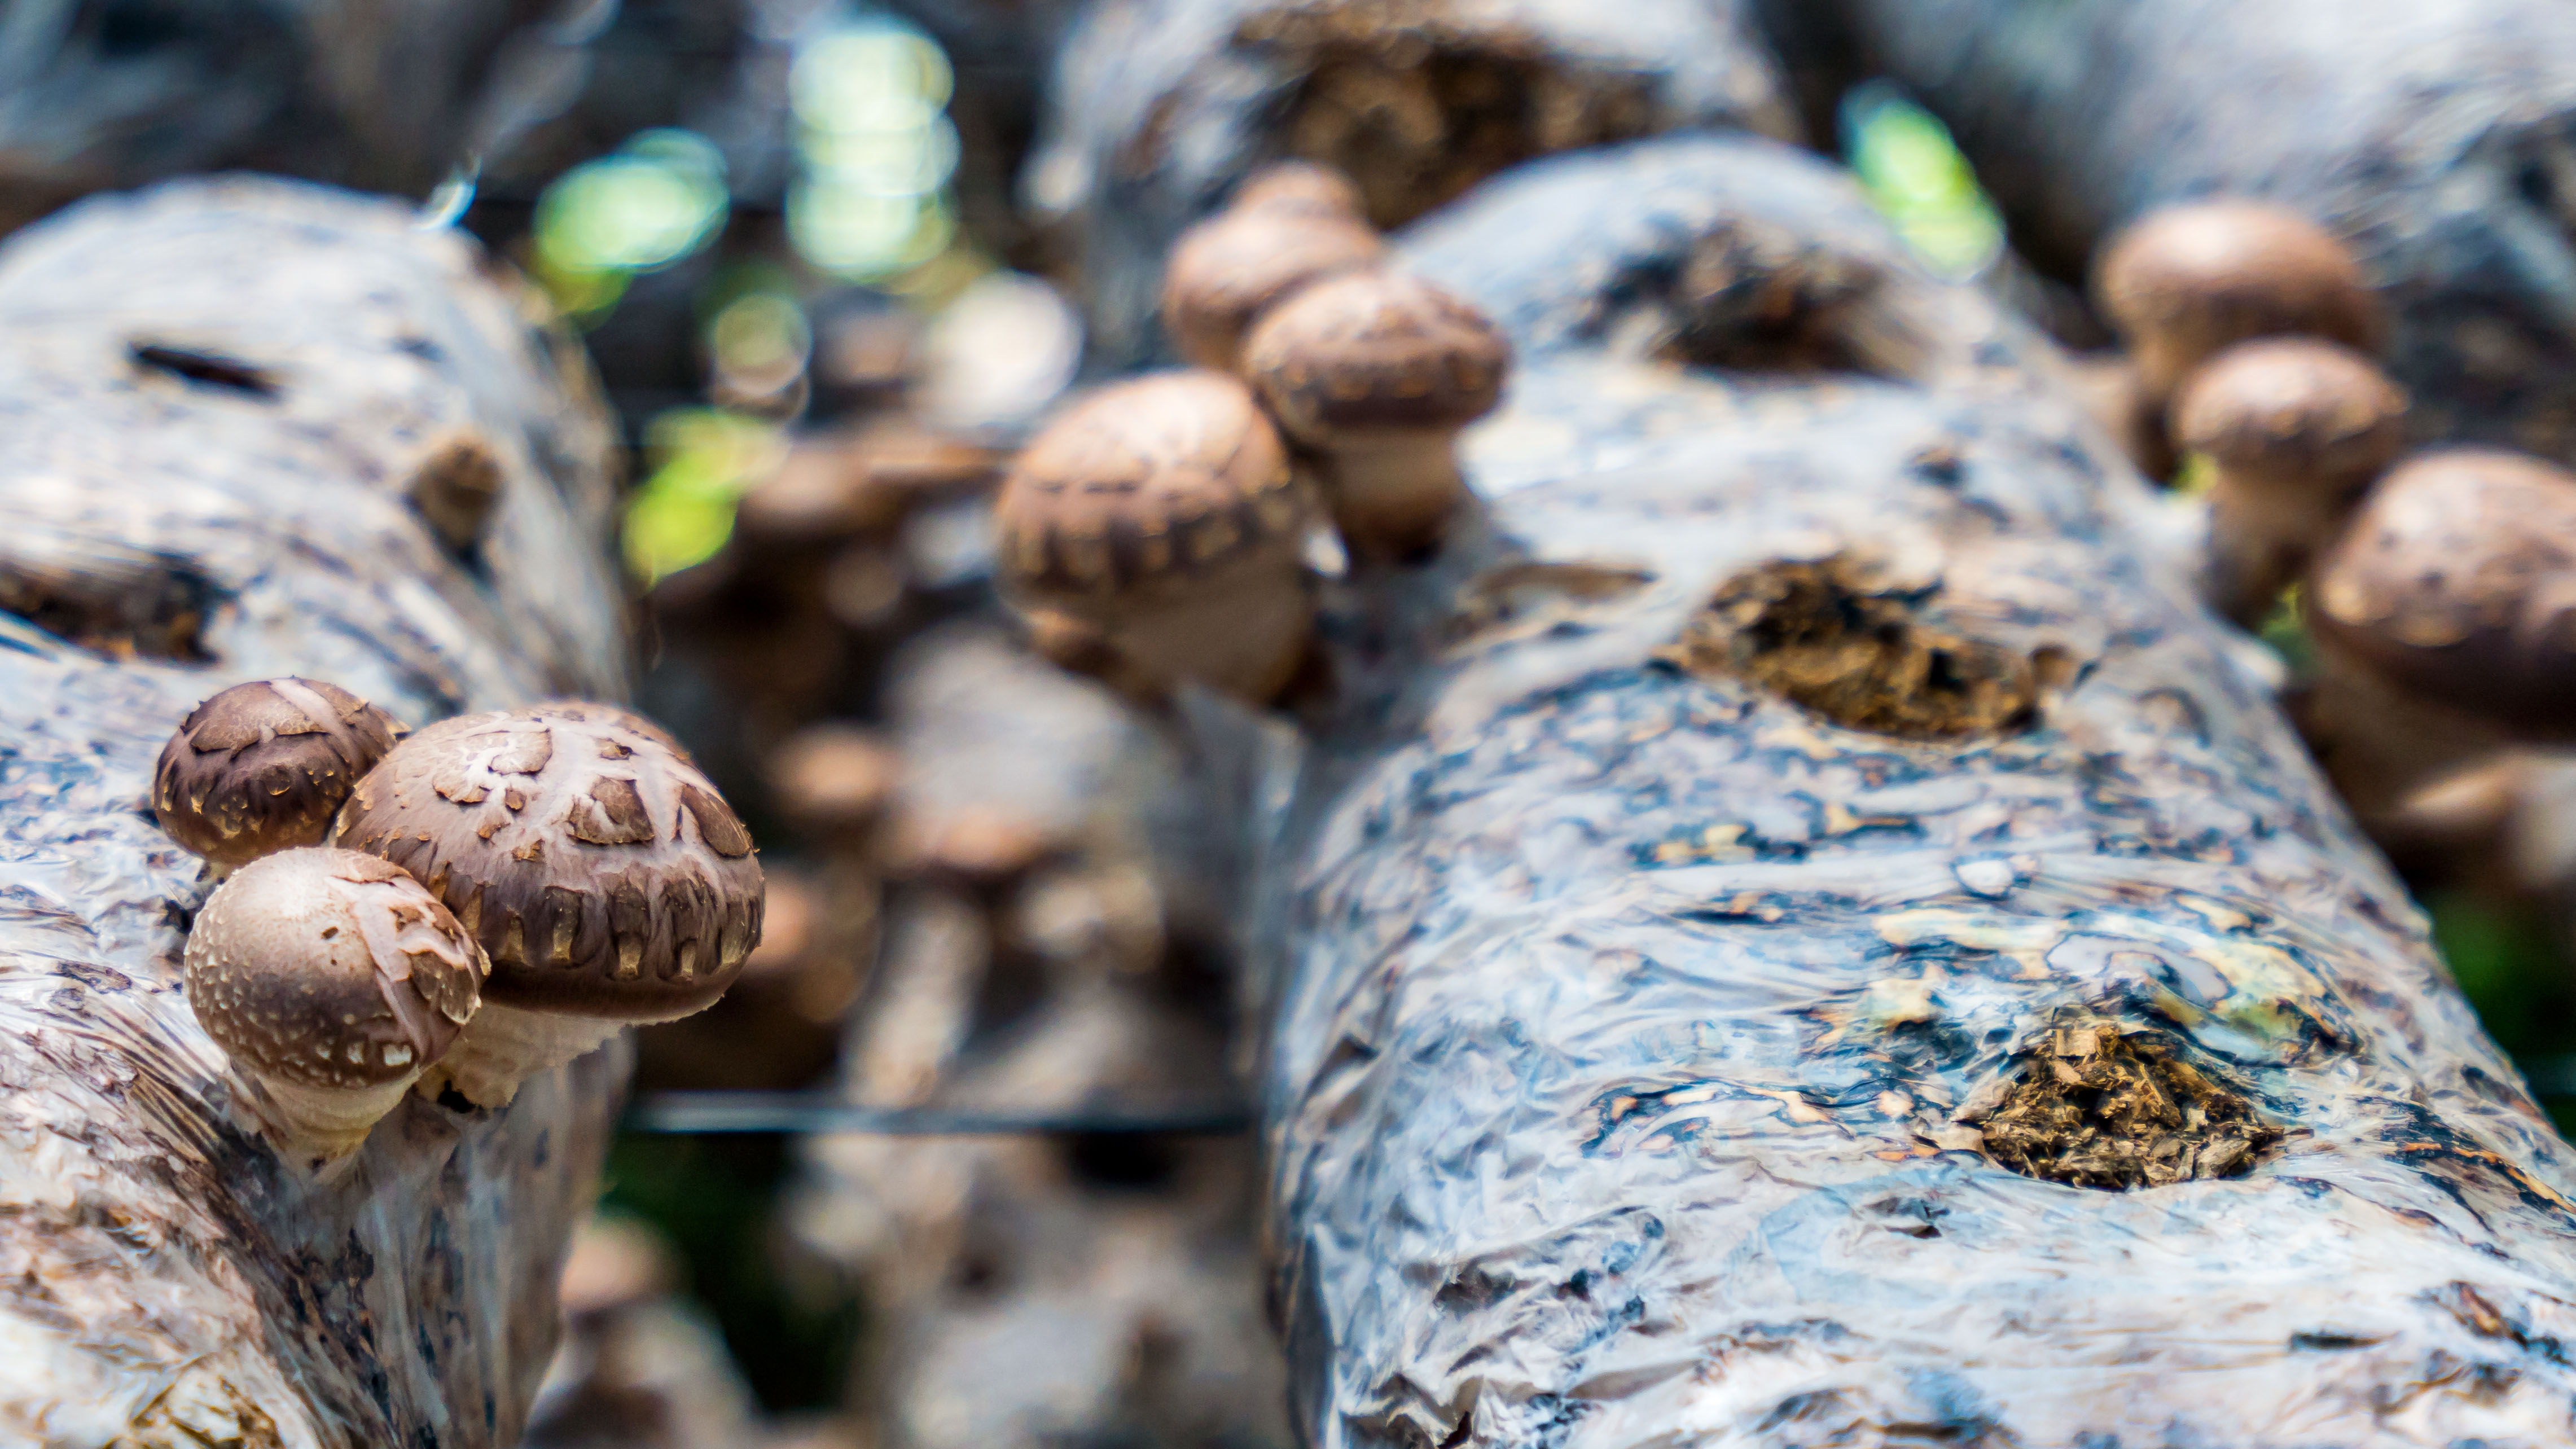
xmin=1765 ymin=0 xmax=2576 ymax=458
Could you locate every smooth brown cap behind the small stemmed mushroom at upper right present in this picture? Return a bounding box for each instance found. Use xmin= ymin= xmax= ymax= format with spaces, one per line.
xmin=2094 ymin=198 xmax=2383 ymax=399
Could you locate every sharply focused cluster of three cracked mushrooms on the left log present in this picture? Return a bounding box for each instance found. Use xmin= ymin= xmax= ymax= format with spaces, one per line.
xmin=152 ymin=679 xmax=760 ymax=1161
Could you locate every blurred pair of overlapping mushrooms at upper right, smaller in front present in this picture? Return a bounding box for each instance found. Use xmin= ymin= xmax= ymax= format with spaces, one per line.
xmin=2097 ymin=201 xmax=2406 ymax=623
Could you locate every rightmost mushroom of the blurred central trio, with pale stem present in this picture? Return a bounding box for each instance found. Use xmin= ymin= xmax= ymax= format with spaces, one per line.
xmin=1244 ymin=270 xmax=1512 ymax=556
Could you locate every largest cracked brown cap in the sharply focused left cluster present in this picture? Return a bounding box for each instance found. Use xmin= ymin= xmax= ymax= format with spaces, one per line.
xmin=332 ymin=702 xmax=760 ymax=1022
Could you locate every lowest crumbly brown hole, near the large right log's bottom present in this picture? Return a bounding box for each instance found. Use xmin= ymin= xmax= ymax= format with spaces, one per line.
xmin=1968 ymin=1017 xmax=2285 ymax=1189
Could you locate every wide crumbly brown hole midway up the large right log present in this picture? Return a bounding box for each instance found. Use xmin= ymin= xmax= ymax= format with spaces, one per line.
xmin=1659 ymin=556 xmax=2074 ymax=739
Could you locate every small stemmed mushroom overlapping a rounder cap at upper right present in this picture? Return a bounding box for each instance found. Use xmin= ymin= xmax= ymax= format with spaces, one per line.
xmin=2174 ymin=337 xmax=2406 ymax=623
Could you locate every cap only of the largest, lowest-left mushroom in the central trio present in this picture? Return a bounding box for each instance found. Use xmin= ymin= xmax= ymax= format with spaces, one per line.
xmin=994 ymin=371 xmax=1314 ymax=610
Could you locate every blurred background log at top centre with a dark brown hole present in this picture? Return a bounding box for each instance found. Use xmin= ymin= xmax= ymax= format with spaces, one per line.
xmin=1022 ymin=0 xmax=1798 ymax=363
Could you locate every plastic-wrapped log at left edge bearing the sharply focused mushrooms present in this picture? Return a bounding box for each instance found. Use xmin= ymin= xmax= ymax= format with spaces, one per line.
xmin=0 ymin=180 xmax=629 ymax=1446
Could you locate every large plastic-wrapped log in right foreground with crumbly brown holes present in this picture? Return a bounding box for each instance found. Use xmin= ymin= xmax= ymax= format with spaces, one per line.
xmin=1215 ymin=139 xmax=2576 ymax=1449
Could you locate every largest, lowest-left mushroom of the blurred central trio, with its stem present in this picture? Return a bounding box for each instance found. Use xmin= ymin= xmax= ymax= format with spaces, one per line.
xmin=994 ymin=371 xmax=1316 ymax=702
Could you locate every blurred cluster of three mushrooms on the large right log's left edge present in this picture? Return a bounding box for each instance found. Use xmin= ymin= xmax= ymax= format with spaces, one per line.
xmin=997 ymin=165 xmax=1509 ymax=702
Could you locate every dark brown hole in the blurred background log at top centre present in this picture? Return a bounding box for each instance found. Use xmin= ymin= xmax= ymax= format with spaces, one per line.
xmin=1234 ymin=0 xmax=1654 ymax=229
